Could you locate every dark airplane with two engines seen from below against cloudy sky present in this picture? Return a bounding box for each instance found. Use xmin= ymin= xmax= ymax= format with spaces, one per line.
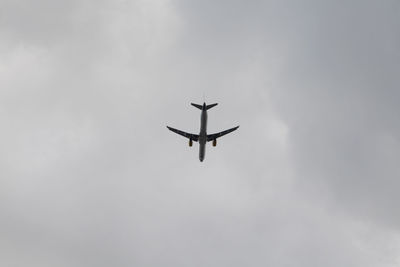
xmin=167 ymin=103 xmax=239 ymax=162
